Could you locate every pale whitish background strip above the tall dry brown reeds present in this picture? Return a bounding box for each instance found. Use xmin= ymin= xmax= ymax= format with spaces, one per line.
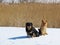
xmin=0 ymin=0 xmax=60 ymax=3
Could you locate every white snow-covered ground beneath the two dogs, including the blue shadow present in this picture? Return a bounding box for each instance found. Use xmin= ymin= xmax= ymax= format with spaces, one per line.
xmin=0 ymin=27 xmax=60 ymax=45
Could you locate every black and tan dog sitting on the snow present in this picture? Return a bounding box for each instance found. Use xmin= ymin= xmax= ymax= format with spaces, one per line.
xmin=26 ymin=22 xmax=39 ymax=37
